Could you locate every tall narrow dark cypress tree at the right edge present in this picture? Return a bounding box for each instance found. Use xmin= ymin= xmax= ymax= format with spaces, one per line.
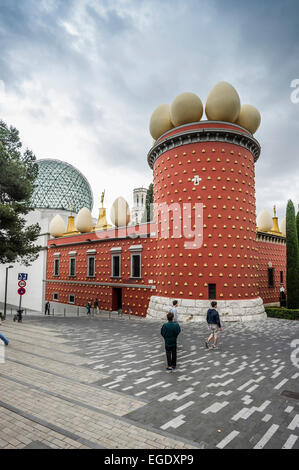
xmin=286 ymin=200 xmax=299 ymax=308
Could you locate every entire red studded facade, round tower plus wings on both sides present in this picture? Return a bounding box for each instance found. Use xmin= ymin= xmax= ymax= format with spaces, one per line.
xmin=46 ymin=122 xmax=286 ymax=316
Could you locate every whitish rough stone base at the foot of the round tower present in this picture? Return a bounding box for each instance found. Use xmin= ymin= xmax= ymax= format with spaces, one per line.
xmin=146 ymin=295 xmax=267 ymax=322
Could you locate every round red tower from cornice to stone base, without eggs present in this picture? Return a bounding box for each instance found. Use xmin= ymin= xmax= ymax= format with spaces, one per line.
xmin=148 ymin=121 xmax=265 ymax=320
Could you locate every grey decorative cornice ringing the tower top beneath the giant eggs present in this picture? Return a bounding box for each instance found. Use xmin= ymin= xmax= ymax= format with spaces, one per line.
xmin=147 ymin=123 xmax=261 ymax=169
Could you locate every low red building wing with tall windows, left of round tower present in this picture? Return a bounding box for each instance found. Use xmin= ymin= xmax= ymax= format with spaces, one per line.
xmin=46 ymin=224 xmax=154 ymax=316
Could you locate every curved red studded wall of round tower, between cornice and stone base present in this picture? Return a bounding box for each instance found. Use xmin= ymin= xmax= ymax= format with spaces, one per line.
xmin=154 ymin=123 xmax=259 ymax=299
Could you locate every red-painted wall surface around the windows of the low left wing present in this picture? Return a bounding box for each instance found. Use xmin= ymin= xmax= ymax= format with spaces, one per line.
xmin=46 ymin=224 xmax=155 ymax=316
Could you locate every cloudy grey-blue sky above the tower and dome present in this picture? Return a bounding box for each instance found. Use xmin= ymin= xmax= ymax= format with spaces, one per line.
xmin=0 ymin=0 xmax=299 ymax=223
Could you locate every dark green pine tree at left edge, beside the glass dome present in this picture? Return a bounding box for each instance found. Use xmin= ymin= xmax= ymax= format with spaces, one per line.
xmin=0 ymin=120 xmax=41 ymax=266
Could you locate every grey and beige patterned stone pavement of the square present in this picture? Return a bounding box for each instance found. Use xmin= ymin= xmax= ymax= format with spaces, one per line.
xmin=0 ymin=314 xmax=299 ymax=449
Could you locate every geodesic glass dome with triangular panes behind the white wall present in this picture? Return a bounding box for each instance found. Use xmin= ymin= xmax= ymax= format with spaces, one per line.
xmin=31 ymin=159 xmax=93 ymax=213
